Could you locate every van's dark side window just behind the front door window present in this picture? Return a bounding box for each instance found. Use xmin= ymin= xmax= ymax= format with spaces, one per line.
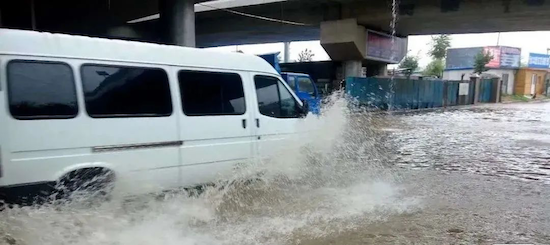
xmin=178 ymin=71 xmax=246 ymax=116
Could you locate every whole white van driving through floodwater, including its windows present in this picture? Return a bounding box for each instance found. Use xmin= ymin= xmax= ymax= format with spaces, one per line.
xmin=0 ymin=29 xmax=307 ymax=203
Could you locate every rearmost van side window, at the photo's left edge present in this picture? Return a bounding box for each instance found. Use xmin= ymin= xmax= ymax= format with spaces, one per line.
xmin=7 ymin=60 xmax=78 ymax=120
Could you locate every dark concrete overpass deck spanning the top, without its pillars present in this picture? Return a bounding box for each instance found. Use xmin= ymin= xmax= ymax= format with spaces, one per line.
xmin=0 ymin=0 xmax=550 ymax=47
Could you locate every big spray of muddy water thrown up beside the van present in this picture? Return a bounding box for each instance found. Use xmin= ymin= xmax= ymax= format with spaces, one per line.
xmin=0 ymin=93 xmax=418 ymax=245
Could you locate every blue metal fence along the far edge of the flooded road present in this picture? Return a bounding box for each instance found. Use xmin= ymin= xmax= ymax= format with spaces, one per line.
xmin=346 ymin=77 xmax=484 ymax=110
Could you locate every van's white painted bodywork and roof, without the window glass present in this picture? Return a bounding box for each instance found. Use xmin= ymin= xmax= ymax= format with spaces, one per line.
xmin=0 ymin=29 xmax=300 ymax=201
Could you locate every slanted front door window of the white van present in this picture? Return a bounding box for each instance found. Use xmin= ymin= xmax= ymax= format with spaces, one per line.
xmin=254 ymin=76 xmax=300 ymax=118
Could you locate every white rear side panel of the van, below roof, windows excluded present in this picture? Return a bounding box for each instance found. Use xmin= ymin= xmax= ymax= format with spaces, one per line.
xmin=3 ymin=56 xmax=183 ymax=192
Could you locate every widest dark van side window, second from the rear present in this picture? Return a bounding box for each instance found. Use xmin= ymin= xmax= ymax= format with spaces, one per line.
xmin=81 ymin=64 xmax=172 ymax=118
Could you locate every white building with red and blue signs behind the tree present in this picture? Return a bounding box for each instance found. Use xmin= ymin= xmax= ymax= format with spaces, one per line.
xmin=443 ymin=46 xmax=521 ymax=94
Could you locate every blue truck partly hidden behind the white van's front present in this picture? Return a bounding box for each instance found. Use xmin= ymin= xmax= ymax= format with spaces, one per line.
xmin=260 ymin=53 xmax=321 ymax=114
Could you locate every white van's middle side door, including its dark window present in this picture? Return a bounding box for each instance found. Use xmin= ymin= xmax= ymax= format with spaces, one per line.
xmin=178 ymin=70 xmax=254 ymax=185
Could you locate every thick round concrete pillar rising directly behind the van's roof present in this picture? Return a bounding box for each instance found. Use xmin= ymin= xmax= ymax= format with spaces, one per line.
xmin=159 ymin=0 xmax=196 ymax=47
